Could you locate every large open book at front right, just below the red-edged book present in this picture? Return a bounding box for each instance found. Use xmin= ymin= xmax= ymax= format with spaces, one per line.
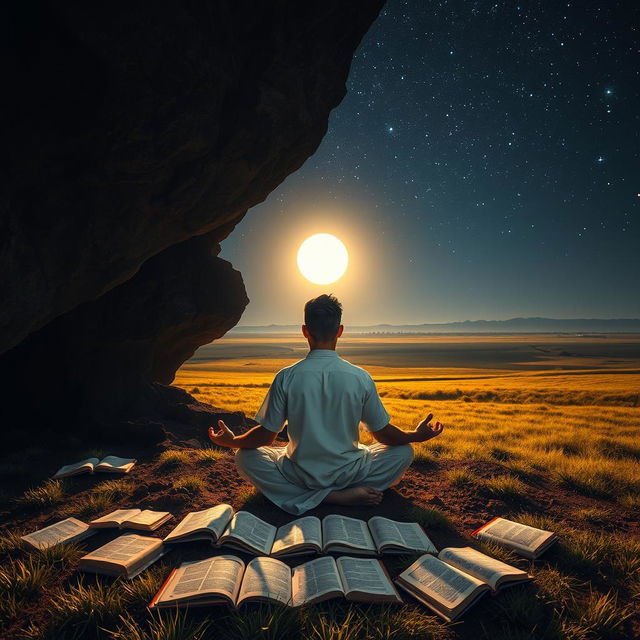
xmin=396 ymin=547 xmax=531 ymax=621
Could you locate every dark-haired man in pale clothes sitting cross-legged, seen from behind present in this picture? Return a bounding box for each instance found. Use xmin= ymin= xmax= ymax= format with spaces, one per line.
xmin=209 ymin=295 xmax=443 ymax=515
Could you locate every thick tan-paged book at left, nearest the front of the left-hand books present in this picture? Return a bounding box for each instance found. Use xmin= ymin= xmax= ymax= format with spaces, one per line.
xmin=78 ymin=533 xmax=167 ymax=578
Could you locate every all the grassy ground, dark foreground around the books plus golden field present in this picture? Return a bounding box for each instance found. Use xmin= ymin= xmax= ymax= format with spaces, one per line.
xmin=0 ymin=337 xmax=640 ymax=640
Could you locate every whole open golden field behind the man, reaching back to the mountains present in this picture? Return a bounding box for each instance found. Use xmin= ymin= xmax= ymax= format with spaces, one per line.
xmin=175 ymin=336 xmax=640 ymax=507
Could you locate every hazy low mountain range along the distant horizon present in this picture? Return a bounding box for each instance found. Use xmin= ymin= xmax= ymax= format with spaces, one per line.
xmin=230 ymin=318 xmax=640 ymax=334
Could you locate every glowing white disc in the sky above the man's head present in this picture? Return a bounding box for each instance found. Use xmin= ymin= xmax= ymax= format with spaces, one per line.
xmin=298 ymin=233 xmax=349 ymax=284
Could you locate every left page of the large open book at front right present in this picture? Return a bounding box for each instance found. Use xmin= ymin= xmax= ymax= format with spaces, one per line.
xmin=400 ymin=555 xmax=483 ymax=609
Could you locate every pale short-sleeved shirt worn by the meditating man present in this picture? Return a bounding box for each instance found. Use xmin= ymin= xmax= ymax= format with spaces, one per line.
xmin=255 ymin=349 xmax=389 ymax=489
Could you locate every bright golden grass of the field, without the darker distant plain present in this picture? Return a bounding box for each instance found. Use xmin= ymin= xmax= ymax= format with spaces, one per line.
xmin=176 ymin=359 xmax=640 ymax=507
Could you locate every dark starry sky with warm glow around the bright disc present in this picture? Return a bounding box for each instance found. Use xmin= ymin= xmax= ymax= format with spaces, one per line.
xmin=221 ymin=0 xmax=640 ymax=325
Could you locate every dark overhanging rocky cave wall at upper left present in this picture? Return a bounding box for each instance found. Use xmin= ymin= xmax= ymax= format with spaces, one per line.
xmin=0 ymin=0 xmax=383 ymax=444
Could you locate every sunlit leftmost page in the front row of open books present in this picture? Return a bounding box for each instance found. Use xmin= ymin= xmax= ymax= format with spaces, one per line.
xmin=158 ymin=556 xmax=244 ymax=603
